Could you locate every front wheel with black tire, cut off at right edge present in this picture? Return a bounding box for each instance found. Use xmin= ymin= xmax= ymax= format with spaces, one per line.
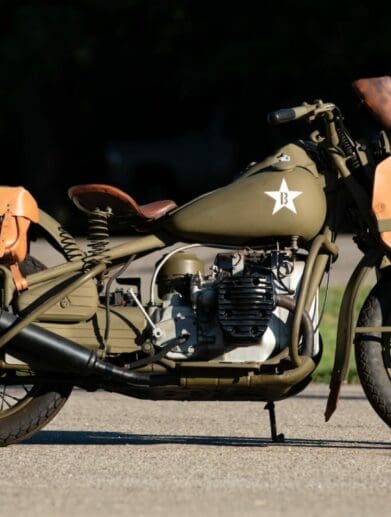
xmin=355 ymin=274 xmax=391 ymax=427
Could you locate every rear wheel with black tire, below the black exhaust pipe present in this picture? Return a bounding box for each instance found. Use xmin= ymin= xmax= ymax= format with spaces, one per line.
xmin=0 ymin=256 xmax=73 ymax=447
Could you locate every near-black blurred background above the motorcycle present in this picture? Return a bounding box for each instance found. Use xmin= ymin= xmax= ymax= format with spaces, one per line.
xmin=0 ymin=0 xmax=391 ymax=226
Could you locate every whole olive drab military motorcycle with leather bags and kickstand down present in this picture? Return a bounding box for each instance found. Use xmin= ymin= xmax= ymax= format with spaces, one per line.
xmin=0 ymin=77 xmax=391 ymax=446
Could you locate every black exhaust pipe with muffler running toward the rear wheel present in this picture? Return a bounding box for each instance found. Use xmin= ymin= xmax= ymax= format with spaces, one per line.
xmin=0 ymin=311 xmax=179 ymax=388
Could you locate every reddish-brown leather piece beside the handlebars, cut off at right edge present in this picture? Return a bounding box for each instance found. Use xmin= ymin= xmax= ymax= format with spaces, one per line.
xmin=353 ymin=75 xmax=391 ymax=129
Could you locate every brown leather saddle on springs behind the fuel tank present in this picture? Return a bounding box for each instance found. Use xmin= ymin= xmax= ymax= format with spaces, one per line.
xmin=68 ymin=183 xmax=177 ymax=222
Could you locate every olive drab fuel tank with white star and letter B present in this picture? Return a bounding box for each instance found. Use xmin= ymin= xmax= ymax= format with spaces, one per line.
xmin=165 ymin=144 xmax=326 ymax=244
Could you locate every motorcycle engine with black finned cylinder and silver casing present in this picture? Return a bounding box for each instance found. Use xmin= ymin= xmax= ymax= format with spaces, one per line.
xmin=153 ymin=248 xmax=319 ymax=363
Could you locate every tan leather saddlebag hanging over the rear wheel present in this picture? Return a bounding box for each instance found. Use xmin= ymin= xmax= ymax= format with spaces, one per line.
xmin=0 ymin=187 xmax=39 ymax=290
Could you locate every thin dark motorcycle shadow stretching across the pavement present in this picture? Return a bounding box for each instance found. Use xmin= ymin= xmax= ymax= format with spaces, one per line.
xmin=23 ymin=431 xmax=391 ymax=450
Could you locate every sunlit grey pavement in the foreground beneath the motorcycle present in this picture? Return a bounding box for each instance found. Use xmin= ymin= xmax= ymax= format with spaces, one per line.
xmin=0 ymin=385 xmax=391 ymax=517
